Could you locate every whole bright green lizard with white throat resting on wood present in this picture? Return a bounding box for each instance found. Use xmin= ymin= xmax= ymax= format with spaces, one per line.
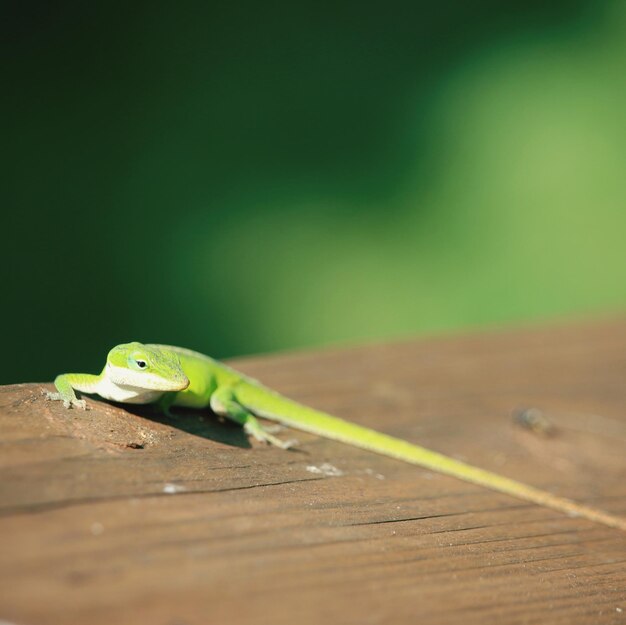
xmin=48 ymin=342 xmax=626 ymax=531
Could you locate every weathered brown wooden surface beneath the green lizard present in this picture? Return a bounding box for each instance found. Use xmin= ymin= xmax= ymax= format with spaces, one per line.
xmin=0 ymin=321 xmax=626 ymax=625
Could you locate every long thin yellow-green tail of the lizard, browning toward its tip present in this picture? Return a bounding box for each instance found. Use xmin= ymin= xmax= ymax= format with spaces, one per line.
xmin=236 ymin=383 xmax=626 ymax=531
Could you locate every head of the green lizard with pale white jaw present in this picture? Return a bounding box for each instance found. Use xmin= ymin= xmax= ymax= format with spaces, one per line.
xmin=105 ymin=342 xmax=189 ymax=391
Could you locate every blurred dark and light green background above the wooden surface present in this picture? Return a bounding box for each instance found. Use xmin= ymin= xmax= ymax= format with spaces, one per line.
xmin=0 ymin=0 xmax=626 ymax=383
